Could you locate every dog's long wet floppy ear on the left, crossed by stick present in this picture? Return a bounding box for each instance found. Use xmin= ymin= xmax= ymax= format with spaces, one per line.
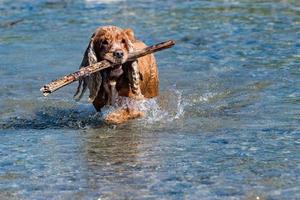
xmin=74 ymin=33 xmax=102 ymax=102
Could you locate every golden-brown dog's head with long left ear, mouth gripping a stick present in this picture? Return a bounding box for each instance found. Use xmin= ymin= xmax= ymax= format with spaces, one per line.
xmin=74 ymin=26 xmax=135 ymax=101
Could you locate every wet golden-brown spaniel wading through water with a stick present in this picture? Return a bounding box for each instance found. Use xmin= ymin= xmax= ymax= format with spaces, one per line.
xmin=74 ymin=26 xmax=159 ymax=124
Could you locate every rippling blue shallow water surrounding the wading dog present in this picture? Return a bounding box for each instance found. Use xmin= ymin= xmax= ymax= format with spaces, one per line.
xmin=0 ymin=0 xmax=300 ymax=200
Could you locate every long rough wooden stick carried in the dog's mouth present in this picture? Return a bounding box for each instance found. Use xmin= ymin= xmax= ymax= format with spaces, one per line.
xmin=40 ymin=40 xmax=175 ymax=96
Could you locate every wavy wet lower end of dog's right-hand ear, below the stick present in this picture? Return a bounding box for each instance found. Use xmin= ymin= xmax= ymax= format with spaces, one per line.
xmin=128 ymin=61 xmax=144 ymax=100
